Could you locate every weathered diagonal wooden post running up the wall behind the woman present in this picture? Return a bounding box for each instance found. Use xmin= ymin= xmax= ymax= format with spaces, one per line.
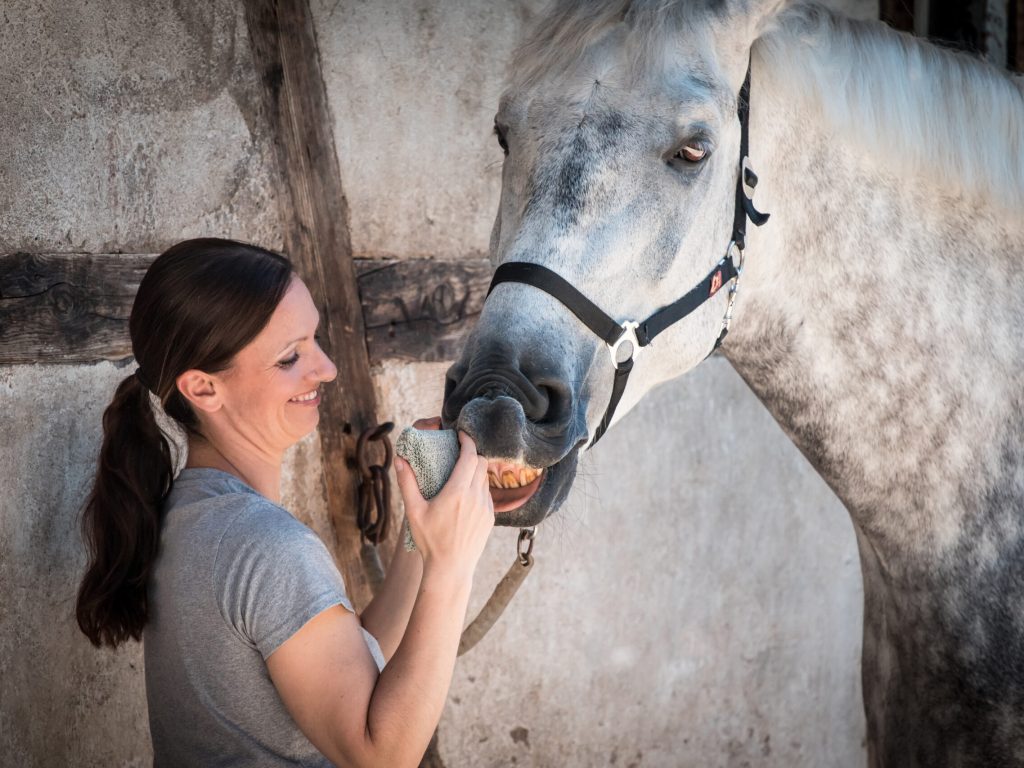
xmin=245 ymin=0 xmax=376 ymax=610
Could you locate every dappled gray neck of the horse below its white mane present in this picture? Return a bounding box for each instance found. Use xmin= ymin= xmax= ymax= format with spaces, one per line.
xmin=724 ymin=58 xmax=1024 ymax=556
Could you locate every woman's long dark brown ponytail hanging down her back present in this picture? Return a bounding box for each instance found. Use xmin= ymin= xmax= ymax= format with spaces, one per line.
xmin=76 ymin=374 xmax=174 ymax=646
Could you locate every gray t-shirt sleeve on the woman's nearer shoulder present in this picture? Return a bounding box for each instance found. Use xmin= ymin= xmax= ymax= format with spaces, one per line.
xmin=213 ymin=501 xmax=352 ymax=658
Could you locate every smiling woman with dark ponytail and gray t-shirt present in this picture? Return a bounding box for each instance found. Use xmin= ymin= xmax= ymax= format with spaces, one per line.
xmin=77 ymin=240 xmax=494 ymax=766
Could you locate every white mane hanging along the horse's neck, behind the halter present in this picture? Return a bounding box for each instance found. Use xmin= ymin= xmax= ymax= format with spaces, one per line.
xmin=755 ymin=4 xmax=1024 ymax=215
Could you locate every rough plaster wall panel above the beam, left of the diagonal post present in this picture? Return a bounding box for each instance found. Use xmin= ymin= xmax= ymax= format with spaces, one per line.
xmin=0 ymin=0 xmax=281 ymax=253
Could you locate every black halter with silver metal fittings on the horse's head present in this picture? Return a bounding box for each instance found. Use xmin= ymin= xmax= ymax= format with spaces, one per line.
xmin=487 ymin=65 xmax=768 ymax=447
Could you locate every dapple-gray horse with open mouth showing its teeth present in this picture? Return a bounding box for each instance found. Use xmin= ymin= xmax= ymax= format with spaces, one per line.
xmin=443 ymin=0 xmax=1024 ymax=766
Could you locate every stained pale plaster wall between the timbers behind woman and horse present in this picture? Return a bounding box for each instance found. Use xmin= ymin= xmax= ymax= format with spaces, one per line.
xmin=0 ymin=0 xmax=877 ymax=768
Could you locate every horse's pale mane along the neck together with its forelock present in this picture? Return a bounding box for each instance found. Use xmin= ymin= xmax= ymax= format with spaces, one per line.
xmin=510 ymin=0 xmax=1024 ymax=211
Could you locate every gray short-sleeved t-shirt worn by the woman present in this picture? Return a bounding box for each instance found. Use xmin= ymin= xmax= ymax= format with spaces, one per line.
xmin=143 ymin=469 xmax=384 ymax=768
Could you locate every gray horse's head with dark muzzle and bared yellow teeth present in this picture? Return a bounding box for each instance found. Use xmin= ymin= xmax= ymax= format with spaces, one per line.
xmin=442 ymin=0 xmax=782 ymax=525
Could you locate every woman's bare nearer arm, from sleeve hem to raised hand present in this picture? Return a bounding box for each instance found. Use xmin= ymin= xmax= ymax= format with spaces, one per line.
xmin=267 ymin=434 xmax=494 ymax=768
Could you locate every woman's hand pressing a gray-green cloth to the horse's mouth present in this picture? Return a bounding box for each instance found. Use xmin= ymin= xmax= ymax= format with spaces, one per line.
xmin=395 ymin=434 xmax=495 ymax=575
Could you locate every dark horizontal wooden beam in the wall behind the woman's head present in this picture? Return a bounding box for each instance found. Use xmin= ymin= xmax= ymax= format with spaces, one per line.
xmin=0 ymin=253 xmax=490 ymax=365
